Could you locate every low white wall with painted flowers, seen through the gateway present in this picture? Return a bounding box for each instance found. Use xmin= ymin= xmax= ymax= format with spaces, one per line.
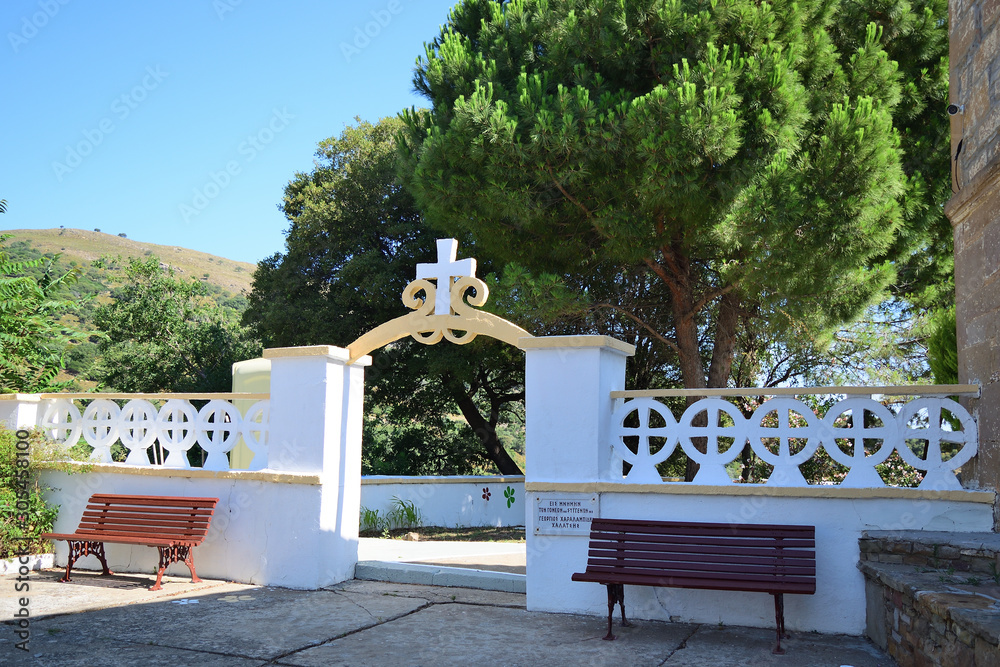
xmin=361 ymin=475 xmax=525 ymax=528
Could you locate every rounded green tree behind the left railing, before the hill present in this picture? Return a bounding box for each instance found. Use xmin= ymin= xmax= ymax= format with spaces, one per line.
xmin=92 ymin=256 xmax=261 ymax=393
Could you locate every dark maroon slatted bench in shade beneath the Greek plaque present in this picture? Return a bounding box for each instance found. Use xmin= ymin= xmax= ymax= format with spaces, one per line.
xmin=573 ymin=519 xmax=816 ymax=654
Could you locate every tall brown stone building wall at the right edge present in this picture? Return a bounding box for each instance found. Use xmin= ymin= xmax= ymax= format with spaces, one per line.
xmin=942 ymin=0 xmax=1000 ymax=512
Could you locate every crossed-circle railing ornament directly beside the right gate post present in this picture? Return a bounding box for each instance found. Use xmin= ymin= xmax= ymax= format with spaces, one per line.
xmin=611 ymin=398 xmax=677 ymax=484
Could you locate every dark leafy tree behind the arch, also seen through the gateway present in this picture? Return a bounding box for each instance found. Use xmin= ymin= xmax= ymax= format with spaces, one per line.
xmin=244 ymin=118 xmax=524 ymax=474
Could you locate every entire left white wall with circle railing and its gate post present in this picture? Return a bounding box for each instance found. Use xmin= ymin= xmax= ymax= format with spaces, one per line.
xmin=0 ymin=345 xmax=371 ymax=589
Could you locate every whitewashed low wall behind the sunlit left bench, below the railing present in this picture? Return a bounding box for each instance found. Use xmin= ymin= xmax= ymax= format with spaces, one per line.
xmin=42 ymin=466 xmax=358 ymax=589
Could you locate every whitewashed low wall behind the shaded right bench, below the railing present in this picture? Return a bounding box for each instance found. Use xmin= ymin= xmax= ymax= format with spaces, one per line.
xmin=526 ymin=483 xmax=994 ymax=635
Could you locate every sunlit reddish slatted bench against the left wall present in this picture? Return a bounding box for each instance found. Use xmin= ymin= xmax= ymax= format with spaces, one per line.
xmin=42 ymin=493 xmax=219 ymax=591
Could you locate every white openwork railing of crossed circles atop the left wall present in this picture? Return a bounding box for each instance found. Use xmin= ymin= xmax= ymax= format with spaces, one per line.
xmin=38 ymin=393 xmax=270 ymax=470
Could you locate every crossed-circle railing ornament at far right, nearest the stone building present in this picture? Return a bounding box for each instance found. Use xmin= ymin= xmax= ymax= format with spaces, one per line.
xmin=896 ymin=397 xmax=979 ymax=491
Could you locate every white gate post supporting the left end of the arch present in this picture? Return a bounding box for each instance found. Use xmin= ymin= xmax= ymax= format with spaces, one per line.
xmin=260 ymin=345 xmax=371 ymax=589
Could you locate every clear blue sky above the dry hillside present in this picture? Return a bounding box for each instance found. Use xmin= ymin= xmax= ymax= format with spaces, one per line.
xmin=0 ymin=0 xmax=454 ymax=262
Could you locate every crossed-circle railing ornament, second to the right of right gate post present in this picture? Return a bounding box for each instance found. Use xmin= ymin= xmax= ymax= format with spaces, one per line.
xmin=677 ymin=398 xmax=747 ymax=485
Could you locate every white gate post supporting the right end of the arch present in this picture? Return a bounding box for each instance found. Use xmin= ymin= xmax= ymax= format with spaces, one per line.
xmin=518 ymin=336 xmax=635 ymax=610
